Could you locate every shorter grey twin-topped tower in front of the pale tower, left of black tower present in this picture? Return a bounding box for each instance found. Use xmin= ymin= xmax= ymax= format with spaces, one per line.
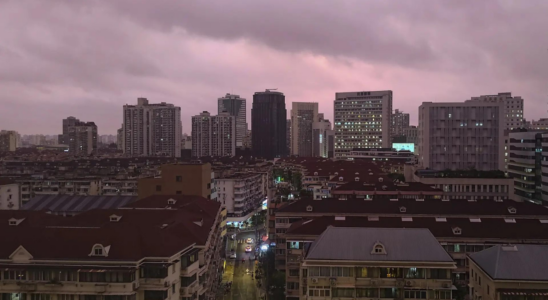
xmin=192 ymin=111 xmax=236 ymax=157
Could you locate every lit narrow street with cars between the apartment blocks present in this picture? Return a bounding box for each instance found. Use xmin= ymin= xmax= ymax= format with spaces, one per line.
xmin=217 ymin=231 xmax=259 ymax=300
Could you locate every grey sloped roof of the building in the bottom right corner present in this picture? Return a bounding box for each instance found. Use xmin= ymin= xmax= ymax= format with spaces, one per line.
xmin=469 ymin=245 xmax=548 ymax=281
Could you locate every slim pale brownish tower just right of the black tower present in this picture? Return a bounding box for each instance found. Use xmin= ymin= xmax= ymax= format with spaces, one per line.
xmin=291 ymin=102 xmax=318 ymax=157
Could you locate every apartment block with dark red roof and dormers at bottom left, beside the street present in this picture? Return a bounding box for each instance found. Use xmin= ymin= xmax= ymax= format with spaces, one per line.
xmin=0 ymin=196 xmax=223 ymax=300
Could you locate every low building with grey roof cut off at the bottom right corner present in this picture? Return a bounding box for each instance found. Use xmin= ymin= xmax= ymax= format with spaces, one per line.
xmin=468 ymin=244 xmax=548 ymax=300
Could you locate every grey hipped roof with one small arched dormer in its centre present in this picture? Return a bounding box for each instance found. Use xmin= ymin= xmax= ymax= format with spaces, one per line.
xmin=306 ymin=226 xmax=453 ymax=262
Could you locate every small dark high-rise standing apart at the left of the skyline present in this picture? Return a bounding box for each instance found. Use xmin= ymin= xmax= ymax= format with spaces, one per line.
xmin=68 ymin=121 xmax=97 ymax=156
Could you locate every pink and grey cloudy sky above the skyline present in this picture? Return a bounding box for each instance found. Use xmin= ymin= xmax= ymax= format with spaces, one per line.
xmin=0 ymin=0 xmax=548 ymax=134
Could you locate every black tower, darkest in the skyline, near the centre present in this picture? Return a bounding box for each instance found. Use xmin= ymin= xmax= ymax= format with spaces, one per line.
xmin=251 ymin=90 xmax=287 ymax=159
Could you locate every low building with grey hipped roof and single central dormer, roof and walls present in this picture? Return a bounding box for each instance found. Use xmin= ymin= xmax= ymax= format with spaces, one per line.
xmin=296 ymin=227 xmax=455 ymax=299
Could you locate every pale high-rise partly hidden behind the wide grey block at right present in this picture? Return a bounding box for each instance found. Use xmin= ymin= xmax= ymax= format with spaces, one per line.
xmin=466 ymin=93 xmax=525 ymax=135
